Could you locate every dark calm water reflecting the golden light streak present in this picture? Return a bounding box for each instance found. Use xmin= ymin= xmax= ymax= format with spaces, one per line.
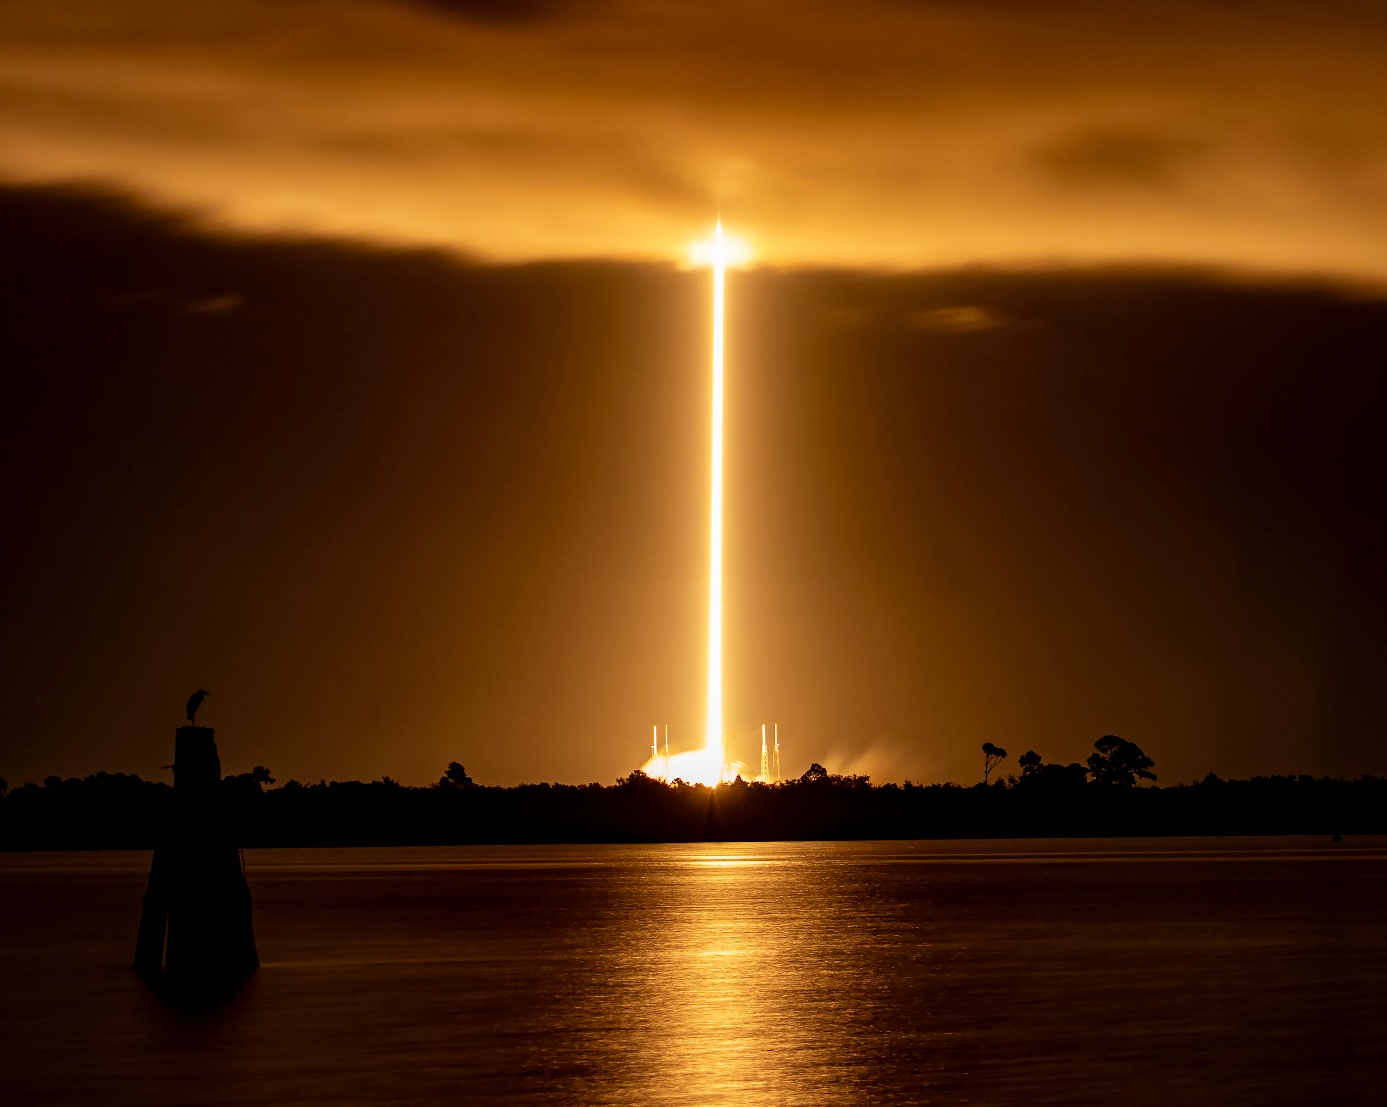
xmin=0 ymin=838 xmax=1387 ymax=1104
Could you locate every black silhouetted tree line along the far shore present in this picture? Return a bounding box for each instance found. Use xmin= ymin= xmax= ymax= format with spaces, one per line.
xmin=0 ymin=734 xmax=1387 ymax=849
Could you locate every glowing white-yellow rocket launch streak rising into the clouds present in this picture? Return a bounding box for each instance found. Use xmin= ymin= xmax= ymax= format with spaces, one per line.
xmin=646 ymin=219 xmax=748 ymax=784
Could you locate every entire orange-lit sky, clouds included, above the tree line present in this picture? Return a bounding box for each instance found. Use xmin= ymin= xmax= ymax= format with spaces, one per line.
xmin=0 ymin=0 xmax=1387 ymax=784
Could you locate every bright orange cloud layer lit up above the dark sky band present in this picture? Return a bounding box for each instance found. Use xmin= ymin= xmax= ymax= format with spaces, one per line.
xmin=0 ymin=0 xmax=1387 ymax=280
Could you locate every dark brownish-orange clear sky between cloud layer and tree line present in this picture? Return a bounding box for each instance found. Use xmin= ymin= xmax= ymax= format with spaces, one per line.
xmin=0 ymin=189 xmax=1387 ymax=784
